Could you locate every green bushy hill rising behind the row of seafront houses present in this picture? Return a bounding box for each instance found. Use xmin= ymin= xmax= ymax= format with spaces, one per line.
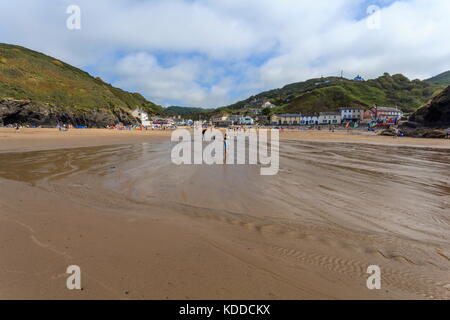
xmin=219 ymin=73 xmax=444 ymax=113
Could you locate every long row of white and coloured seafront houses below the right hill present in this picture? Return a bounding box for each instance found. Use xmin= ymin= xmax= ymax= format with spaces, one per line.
xmin=270 ymin=106 xmax=403 ymax=125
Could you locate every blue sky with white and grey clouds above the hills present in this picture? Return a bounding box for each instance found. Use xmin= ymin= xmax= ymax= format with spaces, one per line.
xmin=0 ymin=0 xmax=450 ymax=108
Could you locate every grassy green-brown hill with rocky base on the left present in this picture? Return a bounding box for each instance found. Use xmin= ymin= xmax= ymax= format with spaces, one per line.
xmin=0 ymin=44 xmax=162 ymax=126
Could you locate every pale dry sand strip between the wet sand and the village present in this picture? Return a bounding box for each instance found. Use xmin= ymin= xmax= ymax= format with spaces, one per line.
xmin=0 ymin=128 xmax=450 ymax=152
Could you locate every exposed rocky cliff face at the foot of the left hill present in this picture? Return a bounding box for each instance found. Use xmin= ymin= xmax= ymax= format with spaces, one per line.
xmin=0 ymin=100 xmax=139 ymax=127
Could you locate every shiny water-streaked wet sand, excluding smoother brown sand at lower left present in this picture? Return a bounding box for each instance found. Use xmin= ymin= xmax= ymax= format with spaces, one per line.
xmin=0 ymin=141 xmax=450 ymax=299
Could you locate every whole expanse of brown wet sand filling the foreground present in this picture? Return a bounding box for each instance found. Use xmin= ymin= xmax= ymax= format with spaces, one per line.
xmin=0 ymin=129 xmax=450 ymax=299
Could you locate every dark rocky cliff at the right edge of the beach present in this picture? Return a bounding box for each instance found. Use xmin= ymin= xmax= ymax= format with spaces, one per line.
xmin=410 ymin=86 xmax=450 ymax=127
